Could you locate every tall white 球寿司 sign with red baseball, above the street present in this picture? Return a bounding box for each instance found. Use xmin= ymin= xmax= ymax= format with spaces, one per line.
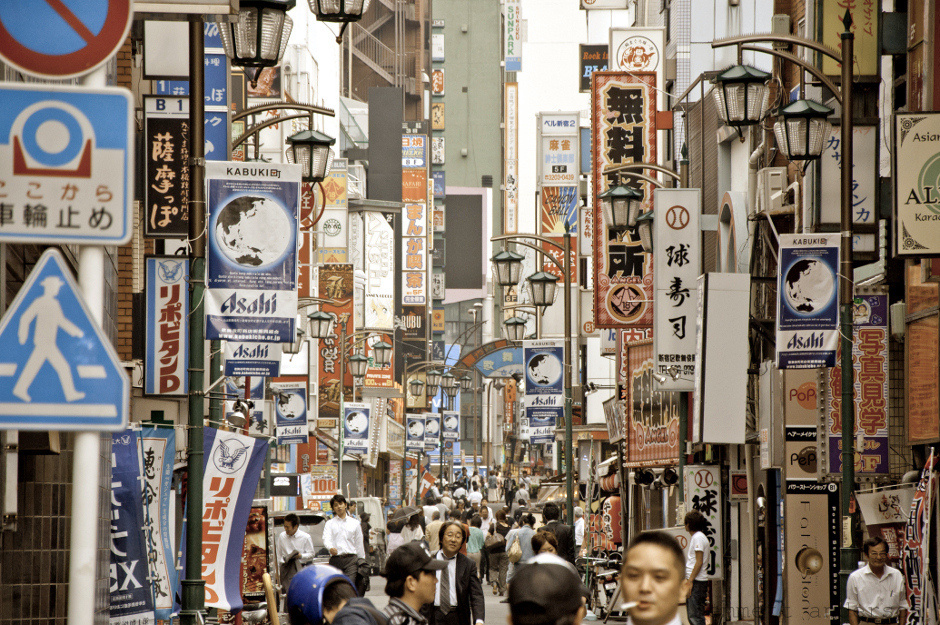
xmin=653 ymin=189 xmax=702 ymax=391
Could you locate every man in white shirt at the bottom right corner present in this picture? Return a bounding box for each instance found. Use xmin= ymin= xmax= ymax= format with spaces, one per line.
xmin=844 ymin=537 xmax=910 ymax=625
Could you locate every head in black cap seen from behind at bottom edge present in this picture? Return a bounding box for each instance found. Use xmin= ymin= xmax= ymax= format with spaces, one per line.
xmin=508 ymin=553 xmax=587 ymax=625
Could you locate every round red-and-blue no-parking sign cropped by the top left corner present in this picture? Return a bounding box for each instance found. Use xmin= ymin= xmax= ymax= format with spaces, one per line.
xmin=0 ymin=0 xmax=133 ymax=78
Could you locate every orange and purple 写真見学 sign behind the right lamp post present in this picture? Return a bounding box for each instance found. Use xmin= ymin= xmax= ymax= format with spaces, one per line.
xmin=825 ymin=295 xmax=889 ymax=475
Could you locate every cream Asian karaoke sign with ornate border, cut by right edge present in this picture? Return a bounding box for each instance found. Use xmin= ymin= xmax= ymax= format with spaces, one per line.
xmin=893 ymin=112 xmax=940 ymax=258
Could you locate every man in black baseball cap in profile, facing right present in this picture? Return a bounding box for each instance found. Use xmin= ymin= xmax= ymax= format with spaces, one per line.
xmin=384 ymin=542 xmax=447 ymax=625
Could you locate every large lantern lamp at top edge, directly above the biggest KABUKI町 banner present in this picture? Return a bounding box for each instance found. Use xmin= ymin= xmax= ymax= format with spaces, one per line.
xmin=218 ymin=0 xmax=297 ymax=85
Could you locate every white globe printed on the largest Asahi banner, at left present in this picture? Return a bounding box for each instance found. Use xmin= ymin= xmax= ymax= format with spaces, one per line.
xmin=215 ymin=195 xmax=294 ymax=268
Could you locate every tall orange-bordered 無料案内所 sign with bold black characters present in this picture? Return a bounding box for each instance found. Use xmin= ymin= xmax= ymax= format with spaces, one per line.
xmin=591 ymin=72 xmax=656 ymax=328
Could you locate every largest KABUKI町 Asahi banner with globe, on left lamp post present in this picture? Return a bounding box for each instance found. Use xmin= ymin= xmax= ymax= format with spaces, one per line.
xmin=205 ymin=161 xmax=300 ymax=343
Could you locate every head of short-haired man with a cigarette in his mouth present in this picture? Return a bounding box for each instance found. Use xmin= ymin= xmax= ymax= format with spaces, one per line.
xmin=620 ymin=531 xmax=691 ymax=625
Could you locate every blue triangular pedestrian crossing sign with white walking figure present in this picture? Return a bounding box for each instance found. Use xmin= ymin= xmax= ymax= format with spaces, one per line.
xmin=0 ymin=249 xmax=130 ymax=431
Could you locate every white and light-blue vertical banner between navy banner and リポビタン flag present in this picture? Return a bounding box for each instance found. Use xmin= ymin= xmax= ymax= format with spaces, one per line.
xmin=140 ymin=428 xmax=177 ymax=621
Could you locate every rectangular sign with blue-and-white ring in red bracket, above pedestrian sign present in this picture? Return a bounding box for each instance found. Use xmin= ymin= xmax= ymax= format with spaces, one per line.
xmin=0 ymin=84 xmax=132 ymax=245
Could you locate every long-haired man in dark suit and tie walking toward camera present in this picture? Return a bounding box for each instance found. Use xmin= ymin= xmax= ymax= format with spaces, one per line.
xmin=422 ymin=521 xmax=485 ymax=625
